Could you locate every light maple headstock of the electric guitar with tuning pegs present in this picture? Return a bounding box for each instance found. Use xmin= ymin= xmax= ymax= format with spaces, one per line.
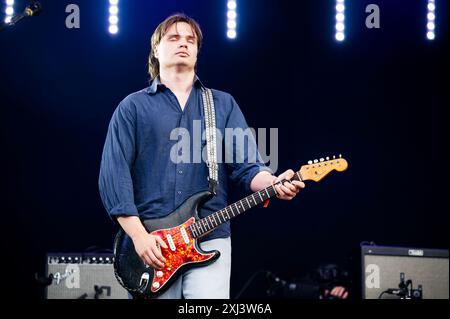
xmin=300 ymin=155 xmax=348 ymax=182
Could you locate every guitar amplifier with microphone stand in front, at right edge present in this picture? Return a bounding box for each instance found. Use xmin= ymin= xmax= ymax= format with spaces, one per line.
xmin=361 ymin=245 xmax=449 ymax=299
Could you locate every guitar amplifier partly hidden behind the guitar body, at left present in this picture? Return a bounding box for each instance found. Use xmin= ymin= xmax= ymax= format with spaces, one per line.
xmin=45 ymin=253 xmax=129 ymax=299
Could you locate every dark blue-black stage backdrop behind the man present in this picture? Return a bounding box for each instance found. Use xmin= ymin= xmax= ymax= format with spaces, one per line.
xmin=0 ymin=0 xmax=449 ymax=298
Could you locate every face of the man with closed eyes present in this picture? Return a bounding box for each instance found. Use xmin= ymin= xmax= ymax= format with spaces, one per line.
xmin=155 ymin=22 xmax=198 ymax=69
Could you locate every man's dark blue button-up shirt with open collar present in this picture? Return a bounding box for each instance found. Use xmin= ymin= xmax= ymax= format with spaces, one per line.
xmin=99 ymin=76 xmax=272 ymax=239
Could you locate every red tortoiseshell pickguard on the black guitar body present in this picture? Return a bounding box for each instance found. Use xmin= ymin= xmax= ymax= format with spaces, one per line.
xmin=150 ymin=217 xmax=214 ymax=292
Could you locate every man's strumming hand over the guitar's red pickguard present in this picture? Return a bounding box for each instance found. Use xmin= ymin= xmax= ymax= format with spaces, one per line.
xmin=132 ymin=233 xmax=167 ymax=269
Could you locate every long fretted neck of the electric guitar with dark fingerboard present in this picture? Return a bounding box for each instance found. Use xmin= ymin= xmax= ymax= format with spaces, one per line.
xmin=189 ymin=171 xmax=303 ymax=238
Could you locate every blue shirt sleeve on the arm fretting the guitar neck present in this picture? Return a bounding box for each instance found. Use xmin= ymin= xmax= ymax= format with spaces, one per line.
xmin=225 ymin=95 xmax=274 ymax=194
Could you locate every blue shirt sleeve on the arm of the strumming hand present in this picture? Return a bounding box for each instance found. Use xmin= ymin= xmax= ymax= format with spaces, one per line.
xmin=98 ymin=98 xmax=139 ymax=220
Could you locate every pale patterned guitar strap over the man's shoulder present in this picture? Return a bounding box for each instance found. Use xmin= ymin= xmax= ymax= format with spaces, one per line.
xmin=202 ymin=86 xmax=219 ymax=195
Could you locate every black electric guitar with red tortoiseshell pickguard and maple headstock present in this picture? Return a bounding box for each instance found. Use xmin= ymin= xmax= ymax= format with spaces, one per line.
xmin=114 ymin=157 xmax=348 ymax=298
